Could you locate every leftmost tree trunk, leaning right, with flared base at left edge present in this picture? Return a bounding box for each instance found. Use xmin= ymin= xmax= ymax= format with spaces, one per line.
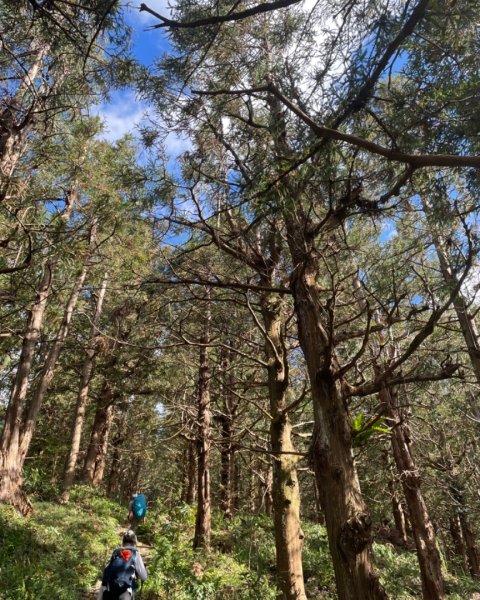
xmin=0 ymin=258 xmax=56 ymax=514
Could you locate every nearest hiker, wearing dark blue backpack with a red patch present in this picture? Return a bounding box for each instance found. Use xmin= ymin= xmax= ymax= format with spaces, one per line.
xmin=98 ymin=529 xmax=148 ymax=600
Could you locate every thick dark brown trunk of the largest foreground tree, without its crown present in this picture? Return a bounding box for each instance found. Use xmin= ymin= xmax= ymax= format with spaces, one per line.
xmin=287 ymin=260 xmax=387 ymax=600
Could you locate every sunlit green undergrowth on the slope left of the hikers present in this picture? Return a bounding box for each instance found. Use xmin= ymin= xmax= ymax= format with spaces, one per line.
xmin=0 ymin=488 xmax=124 ymax=600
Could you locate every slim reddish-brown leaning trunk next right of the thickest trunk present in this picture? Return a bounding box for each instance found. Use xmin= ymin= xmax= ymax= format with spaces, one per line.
xmin=380 ymin=386 xmax=446 ymax=600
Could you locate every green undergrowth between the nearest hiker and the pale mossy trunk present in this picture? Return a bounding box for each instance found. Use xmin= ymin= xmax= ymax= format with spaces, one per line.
xmin=142 ymin=506 xmax=278 ymax=600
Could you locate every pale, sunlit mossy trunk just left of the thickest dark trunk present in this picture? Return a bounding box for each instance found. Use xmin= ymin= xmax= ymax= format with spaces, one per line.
xmin=262 ymin=294 xmax=307 ymax=600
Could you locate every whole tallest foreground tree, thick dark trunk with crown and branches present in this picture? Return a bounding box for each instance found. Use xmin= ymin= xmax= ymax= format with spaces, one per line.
xmin=139 ymin=2 xmax=478 ymax=598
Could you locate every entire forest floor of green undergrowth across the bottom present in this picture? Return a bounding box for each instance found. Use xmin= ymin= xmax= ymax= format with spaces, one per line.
xmin=0 ymin=486 xmax=480 ymax=600
